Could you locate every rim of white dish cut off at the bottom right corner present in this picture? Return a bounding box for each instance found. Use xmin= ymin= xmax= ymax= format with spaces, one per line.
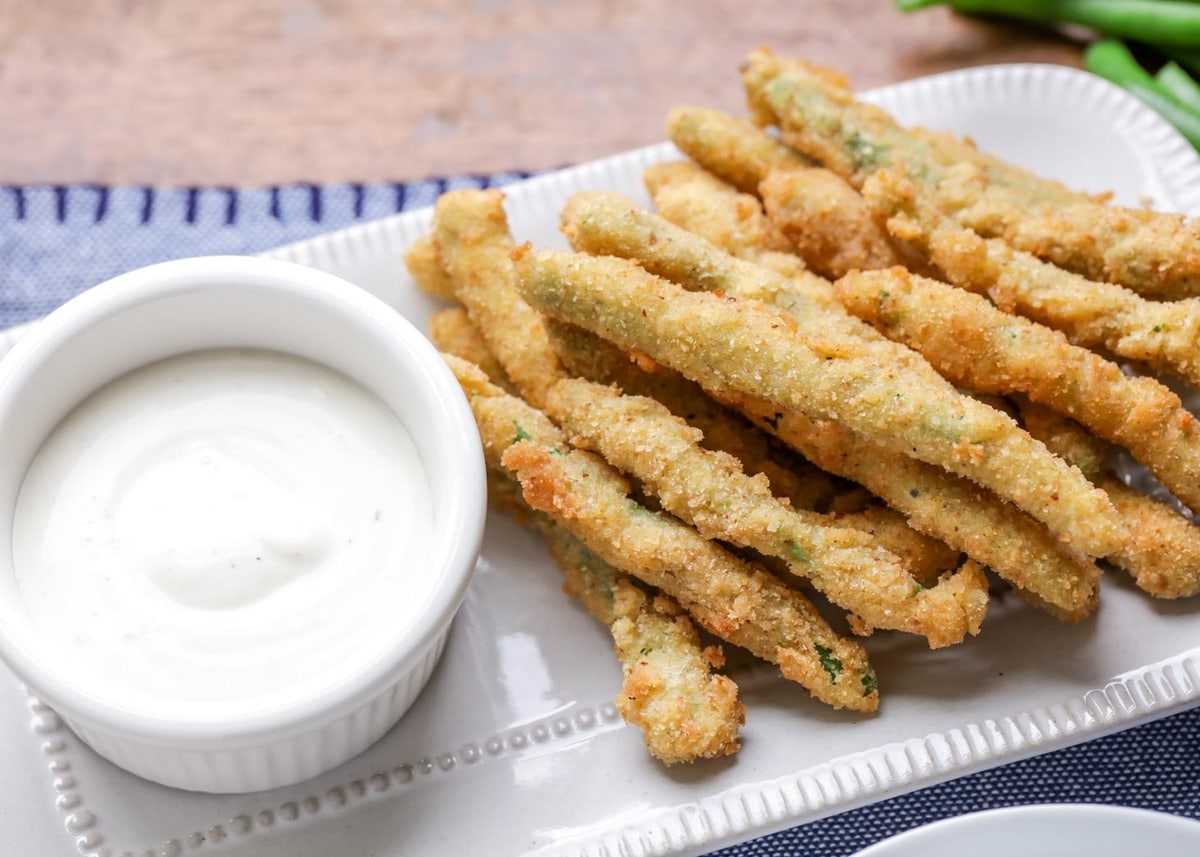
xmin=857 ymin=803 xmax=1200 ymax=857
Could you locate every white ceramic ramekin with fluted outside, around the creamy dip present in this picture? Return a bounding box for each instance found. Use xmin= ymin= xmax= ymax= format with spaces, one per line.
xmin=0 ymin=257 xmax=486 ymax=792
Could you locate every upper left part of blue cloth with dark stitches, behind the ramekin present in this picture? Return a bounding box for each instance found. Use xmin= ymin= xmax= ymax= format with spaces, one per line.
xmin=0 ymin=173 xmax=524 ymax=329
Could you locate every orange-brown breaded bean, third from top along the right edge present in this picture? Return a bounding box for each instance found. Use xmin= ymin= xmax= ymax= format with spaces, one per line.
xmin=836 ymin=268 xmax=1200 ymax=513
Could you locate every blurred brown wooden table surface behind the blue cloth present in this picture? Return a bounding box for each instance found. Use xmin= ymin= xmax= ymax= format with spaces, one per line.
xmin=0 ymin=0 xmax=1080 ymax=185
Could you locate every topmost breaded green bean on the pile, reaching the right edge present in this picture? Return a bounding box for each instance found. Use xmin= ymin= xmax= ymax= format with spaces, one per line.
xmin=743 ymin=49 xmax=1200 ymax=299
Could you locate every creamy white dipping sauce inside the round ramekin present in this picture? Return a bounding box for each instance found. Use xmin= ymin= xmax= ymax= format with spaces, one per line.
xmin=13 ymin=349 xmax=437 ymax=713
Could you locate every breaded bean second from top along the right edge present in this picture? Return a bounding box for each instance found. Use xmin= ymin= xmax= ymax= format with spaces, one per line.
xmin=929 ymin=230 xmax=1200 ymax=386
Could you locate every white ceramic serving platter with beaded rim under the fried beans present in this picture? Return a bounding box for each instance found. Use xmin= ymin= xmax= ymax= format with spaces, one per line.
xmin=0 ymin=65 xmax=1200 ymax=857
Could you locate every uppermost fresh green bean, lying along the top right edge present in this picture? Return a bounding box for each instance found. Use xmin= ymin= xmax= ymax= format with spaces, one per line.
xmin=896 ymin=0 xmax=1200 ymax=48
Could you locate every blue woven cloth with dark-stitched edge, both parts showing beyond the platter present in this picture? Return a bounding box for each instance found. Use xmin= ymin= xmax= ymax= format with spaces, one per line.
xmin=0 ymin=180 xmax=1200 ymax=857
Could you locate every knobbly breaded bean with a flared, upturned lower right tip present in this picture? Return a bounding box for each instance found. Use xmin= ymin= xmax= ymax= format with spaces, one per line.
xmin=546 ymin=379 xmax=988 ymax=648
